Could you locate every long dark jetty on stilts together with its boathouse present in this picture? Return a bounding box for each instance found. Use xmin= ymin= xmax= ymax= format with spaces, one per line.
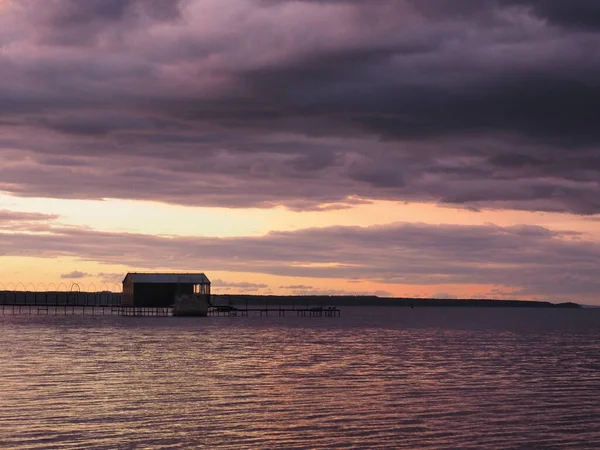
xmin=0 ymin=272 xmax=341 ymax=317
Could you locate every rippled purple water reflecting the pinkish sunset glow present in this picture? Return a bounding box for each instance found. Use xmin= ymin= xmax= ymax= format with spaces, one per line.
xmin=0 ymin=308 xmax=600 ymax=449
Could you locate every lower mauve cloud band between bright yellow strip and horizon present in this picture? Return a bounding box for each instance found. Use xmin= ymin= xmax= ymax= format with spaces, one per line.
xmin=0 ymin=223 xmax=600 ymax=301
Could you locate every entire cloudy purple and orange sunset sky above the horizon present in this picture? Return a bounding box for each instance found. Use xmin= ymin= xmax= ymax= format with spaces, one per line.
xmin=0 ymin=0 xmax=600 ymax=305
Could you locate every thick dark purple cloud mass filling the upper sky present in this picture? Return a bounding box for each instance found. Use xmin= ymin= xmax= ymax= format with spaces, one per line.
xmin=0 ymin=0 xmax=600 ymax=214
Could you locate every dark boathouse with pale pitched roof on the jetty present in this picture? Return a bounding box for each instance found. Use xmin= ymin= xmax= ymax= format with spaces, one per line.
xmin=122 ymin=273 xmax=210 ymax=308
